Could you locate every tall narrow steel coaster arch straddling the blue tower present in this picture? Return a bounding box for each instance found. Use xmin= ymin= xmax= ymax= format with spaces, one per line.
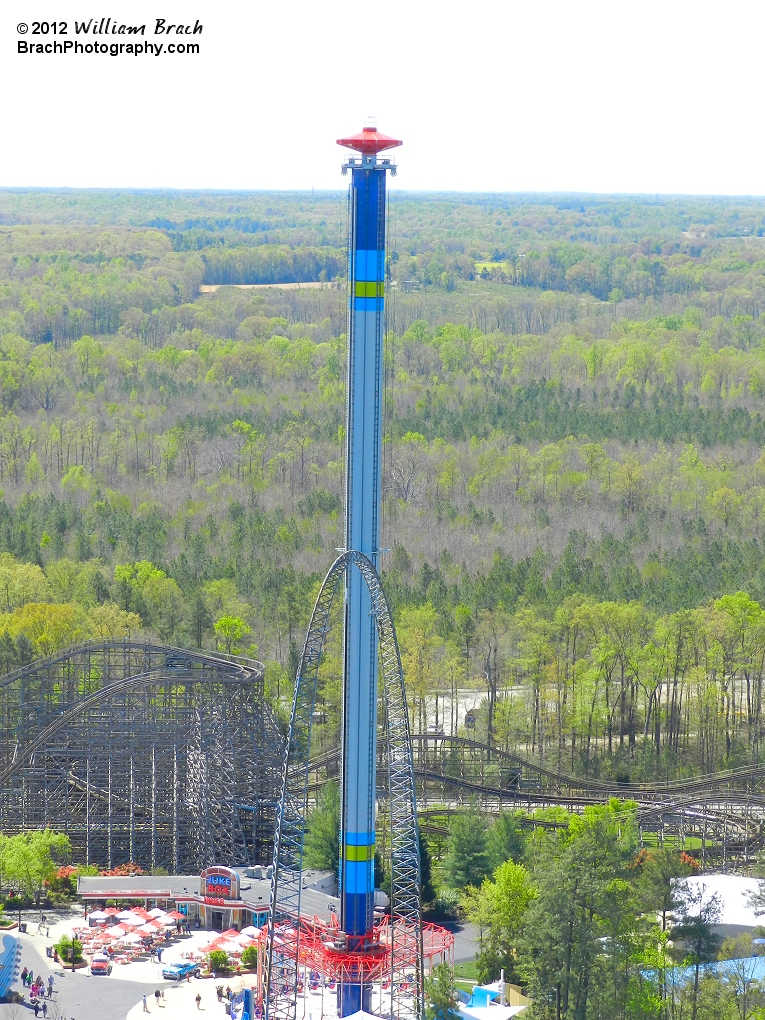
xmin=264 ymin=551 xmax=428 ymax=1020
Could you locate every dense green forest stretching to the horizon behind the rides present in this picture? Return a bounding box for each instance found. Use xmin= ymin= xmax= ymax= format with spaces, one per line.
xmin=0 ymin=190 xmax=765 ymax=779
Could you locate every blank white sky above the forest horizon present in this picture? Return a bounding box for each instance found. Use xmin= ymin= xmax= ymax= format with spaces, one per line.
xmin=0 ymin=0 xmax=765 ymax=195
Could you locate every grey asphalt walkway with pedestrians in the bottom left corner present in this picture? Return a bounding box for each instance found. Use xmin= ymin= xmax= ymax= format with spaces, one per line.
xmin=0 ymin=936 xmax=156 ymax=1020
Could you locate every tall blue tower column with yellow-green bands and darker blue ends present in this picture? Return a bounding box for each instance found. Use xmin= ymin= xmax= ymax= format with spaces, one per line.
xmin=339 ymin=147 xmax=391 ymax=1016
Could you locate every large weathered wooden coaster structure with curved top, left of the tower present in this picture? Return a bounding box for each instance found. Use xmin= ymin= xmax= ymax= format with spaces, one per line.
xmin=0 ymin=641 xmax=284 ymax=874
